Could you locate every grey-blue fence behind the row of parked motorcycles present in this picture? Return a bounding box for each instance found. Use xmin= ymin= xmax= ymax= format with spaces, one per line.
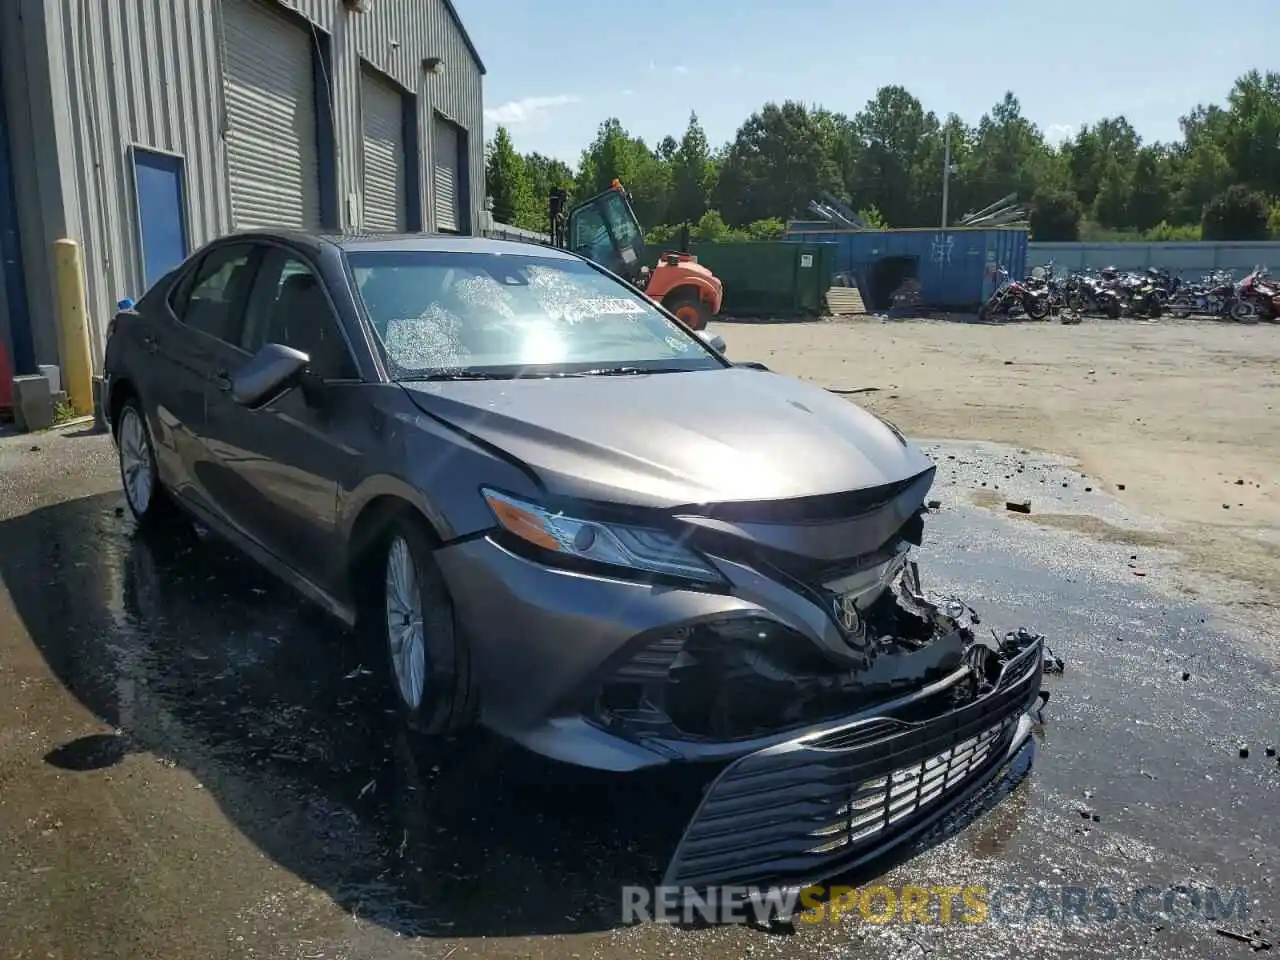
xmin=1027 ymin=241 xmax=1280 ymax=279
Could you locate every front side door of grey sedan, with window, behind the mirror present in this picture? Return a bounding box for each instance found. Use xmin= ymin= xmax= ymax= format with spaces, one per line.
xmin=207 ymin=247 xmax=360 ymax=589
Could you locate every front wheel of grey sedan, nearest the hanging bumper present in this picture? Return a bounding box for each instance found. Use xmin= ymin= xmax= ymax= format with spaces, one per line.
xmin=370 ymin=516 xmax=474 ymax=736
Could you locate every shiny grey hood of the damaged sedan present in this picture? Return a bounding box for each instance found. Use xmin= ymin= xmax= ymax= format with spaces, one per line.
xmin=403 ymin=367 xmax=932 ymax=507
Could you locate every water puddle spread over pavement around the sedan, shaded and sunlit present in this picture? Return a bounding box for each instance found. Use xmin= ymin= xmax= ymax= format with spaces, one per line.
xmin=0 ymin=451 xmax=1280 ymax=956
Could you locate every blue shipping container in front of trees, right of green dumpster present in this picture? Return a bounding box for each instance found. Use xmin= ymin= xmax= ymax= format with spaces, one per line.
xmin=787 ymin=227 xmax=1027 ymax=311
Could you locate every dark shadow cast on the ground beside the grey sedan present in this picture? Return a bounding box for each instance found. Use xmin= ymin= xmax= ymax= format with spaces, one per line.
xmin=0 ymin=494 xmax=1020 ymax=937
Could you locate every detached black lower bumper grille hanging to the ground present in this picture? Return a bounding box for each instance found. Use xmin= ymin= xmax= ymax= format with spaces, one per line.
xmin=663 ymin=637 xmax=1043 ymax=890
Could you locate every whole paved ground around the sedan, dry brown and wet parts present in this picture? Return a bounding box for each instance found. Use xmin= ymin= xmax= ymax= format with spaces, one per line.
xmin=0 ymin=434 xmax=1280 ymax=959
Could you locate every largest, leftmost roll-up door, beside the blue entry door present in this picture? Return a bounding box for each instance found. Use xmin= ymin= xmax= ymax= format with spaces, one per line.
xmin=223 ymin=0 xmax=320 ymax=230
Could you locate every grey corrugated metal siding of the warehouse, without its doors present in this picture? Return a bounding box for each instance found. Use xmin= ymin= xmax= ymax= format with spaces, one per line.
xmin=35 ymin=0 xmax=484 ymax=362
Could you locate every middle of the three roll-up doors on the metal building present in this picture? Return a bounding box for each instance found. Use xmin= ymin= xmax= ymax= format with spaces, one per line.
xmin=360 ymin=70 xmax=408 ymax=230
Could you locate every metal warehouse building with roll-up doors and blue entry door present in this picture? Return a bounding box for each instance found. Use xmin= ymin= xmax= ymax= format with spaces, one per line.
xmin=0 ymin=0 xmax=484 ymax=384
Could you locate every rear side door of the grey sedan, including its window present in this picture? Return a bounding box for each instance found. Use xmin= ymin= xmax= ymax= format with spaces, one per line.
xmin=140 ymin=243 xmax=256 ymax=508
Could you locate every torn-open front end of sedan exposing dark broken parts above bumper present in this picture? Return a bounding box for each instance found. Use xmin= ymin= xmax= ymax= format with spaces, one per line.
xmin=595 ymin=553 xmax=1034 ymax=741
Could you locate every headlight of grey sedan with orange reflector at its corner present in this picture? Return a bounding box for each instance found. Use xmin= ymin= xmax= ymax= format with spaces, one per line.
xmin=481 ymin=488 xmax=724 ymax=584
